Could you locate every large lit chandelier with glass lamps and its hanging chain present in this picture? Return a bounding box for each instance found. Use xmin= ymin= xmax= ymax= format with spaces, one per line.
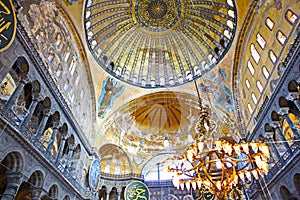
xmin=168 ymin=81 xmax=270 ymax=199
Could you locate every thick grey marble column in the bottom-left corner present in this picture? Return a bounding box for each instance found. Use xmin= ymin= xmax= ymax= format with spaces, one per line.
xmin=1 ymin=173 xmax=23 ymax=200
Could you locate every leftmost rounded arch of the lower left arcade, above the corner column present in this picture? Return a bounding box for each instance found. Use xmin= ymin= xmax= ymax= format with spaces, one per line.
xmin=1 ymin=151 xmax=24 ymax=173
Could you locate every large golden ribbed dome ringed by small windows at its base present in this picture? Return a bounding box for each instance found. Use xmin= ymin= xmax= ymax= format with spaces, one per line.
xmin=85 ymin=0 xmax=237 ymax=88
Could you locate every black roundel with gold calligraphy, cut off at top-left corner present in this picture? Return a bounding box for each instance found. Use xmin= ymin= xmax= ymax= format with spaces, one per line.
xmin=0 ymin=0 xmax=17 ymax=52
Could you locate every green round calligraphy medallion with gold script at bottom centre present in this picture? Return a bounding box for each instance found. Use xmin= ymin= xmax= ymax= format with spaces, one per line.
xmin=124 ymin=181 xmax=150 ymax=200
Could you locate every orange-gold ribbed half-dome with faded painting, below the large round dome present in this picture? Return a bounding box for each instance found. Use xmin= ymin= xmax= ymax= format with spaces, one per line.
xmin=101 ymin=91 xmax=237 ymax=155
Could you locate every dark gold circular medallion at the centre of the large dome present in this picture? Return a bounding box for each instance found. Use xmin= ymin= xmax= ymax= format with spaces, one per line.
xmin=134 ymin=0 xmax=181 ymax=32
